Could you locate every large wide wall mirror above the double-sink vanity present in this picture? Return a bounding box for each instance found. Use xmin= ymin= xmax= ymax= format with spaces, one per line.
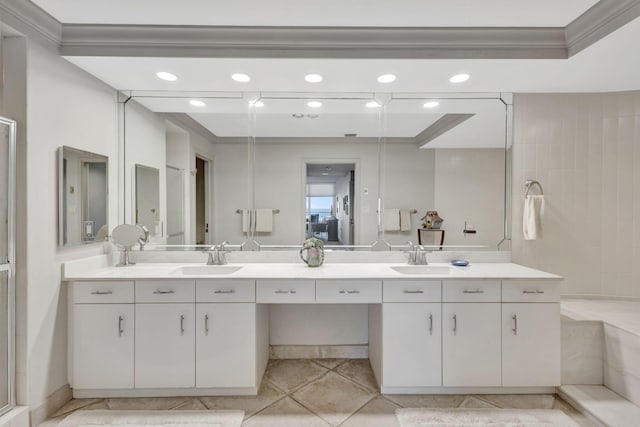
xmin=124 ymin=93 xmax=511 ymax=250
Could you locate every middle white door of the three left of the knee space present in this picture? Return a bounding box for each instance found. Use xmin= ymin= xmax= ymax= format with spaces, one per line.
xmin=135 ymin=304 xmax=195 ymax=388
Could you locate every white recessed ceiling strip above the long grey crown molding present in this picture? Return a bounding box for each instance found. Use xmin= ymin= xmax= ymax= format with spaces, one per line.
xmin=34 ymin=0 xmax=597 ymax=27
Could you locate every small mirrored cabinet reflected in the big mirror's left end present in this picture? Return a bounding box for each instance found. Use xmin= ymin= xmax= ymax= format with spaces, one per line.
xmin=135 ymin=165 xmax=162 ymax=236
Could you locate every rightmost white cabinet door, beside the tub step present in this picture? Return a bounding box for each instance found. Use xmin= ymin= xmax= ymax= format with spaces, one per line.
xmin=502 ymin=303 xmax=560 ymax=387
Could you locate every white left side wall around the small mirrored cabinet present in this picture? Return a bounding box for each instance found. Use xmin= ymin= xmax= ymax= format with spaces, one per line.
xmin=24 ymin=44 xmax=118 ymax=409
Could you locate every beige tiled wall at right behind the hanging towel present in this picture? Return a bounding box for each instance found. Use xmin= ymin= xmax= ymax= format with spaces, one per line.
xmin=512 ymin=91 xmax=640 ymax=297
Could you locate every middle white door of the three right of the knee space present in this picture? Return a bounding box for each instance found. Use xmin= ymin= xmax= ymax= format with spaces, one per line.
xmin=442 ymin=303 xmax=502 ymax=387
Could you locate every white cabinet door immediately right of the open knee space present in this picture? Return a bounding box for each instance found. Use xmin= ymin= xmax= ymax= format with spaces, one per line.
xmin=382 ymin=303 xmax=442 ymax=387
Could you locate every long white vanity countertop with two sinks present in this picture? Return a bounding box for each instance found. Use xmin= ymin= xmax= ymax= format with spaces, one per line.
xmin=63 ymin=262 xmax=562 ymax=281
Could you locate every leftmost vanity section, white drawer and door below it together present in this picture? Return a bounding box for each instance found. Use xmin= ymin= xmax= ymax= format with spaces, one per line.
xmin=69 ymin=281 xmax=134 ymax=389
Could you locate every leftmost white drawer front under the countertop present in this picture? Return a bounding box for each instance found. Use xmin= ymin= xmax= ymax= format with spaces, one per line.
xmin=73 ymin=280 xmax=133 ymax=304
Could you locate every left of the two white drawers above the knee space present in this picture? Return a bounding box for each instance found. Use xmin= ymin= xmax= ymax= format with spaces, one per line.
xmin=256 ymin=279 xmax=316 ymax=304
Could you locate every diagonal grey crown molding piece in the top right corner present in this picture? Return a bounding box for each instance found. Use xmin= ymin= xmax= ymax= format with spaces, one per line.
xmin=565 ymin=0 xmax=640 ymax=57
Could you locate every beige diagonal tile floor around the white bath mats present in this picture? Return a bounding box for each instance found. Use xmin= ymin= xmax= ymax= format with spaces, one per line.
xmin=41 ymin=359 xmax=593 ymax=427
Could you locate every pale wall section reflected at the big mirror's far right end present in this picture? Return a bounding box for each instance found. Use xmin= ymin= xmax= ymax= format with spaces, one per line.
xmin=432 ymin=148 xmax=505 ymax=248
